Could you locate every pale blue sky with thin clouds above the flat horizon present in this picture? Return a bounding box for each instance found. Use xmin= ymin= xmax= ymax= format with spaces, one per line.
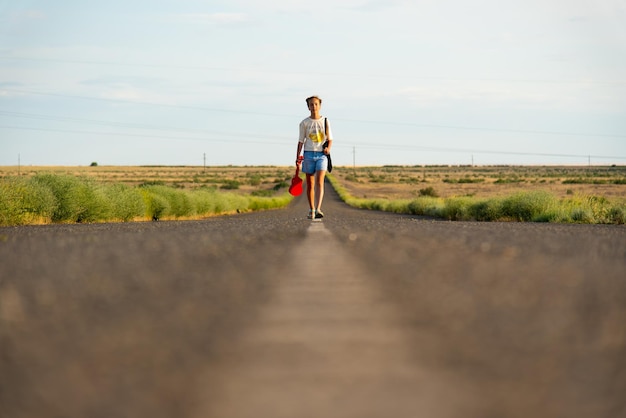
xmin=0 ymin=0 xmax=626 ymax=165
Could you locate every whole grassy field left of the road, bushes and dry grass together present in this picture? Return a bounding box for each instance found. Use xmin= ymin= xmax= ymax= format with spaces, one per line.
xmin=0 ymin=167 xmax=292 ymax=226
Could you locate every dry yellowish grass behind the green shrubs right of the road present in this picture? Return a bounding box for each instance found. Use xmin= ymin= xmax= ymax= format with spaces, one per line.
xmin=333 ymin=166 xmax=626 ymax=199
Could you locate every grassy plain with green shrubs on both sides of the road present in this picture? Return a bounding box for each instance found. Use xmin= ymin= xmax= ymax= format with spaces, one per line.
xmin=0 ymin=166 xmax=626 ymax=225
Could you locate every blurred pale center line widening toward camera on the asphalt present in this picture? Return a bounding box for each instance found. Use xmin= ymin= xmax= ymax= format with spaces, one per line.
xmin=198 ymin=222 xmax=468 ymax=418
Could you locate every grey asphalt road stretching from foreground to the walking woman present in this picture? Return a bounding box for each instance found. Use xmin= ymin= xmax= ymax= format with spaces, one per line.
xmin=0 ymin=184 xmax=626 ymax=418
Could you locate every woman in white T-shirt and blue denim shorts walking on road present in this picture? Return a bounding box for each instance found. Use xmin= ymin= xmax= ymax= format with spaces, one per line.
xmin=296 ymin=96 xmax=333 ymax=219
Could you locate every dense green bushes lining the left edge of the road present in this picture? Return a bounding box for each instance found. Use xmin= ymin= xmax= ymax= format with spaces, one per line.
xmin=0 ymin=168 xmax=292 ymax=226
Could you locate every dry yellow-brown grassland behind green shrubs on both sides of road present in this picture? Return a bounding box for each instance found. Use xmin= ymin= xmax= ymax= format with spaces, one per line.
xmin=0 ymin=166 xmax=626 ymax=200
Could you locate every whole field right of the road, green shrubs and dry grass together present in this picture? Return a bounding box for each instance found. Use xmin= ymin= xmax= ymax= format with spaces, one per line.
xmin=328 ymin=167 xmax=626 ymax=224
